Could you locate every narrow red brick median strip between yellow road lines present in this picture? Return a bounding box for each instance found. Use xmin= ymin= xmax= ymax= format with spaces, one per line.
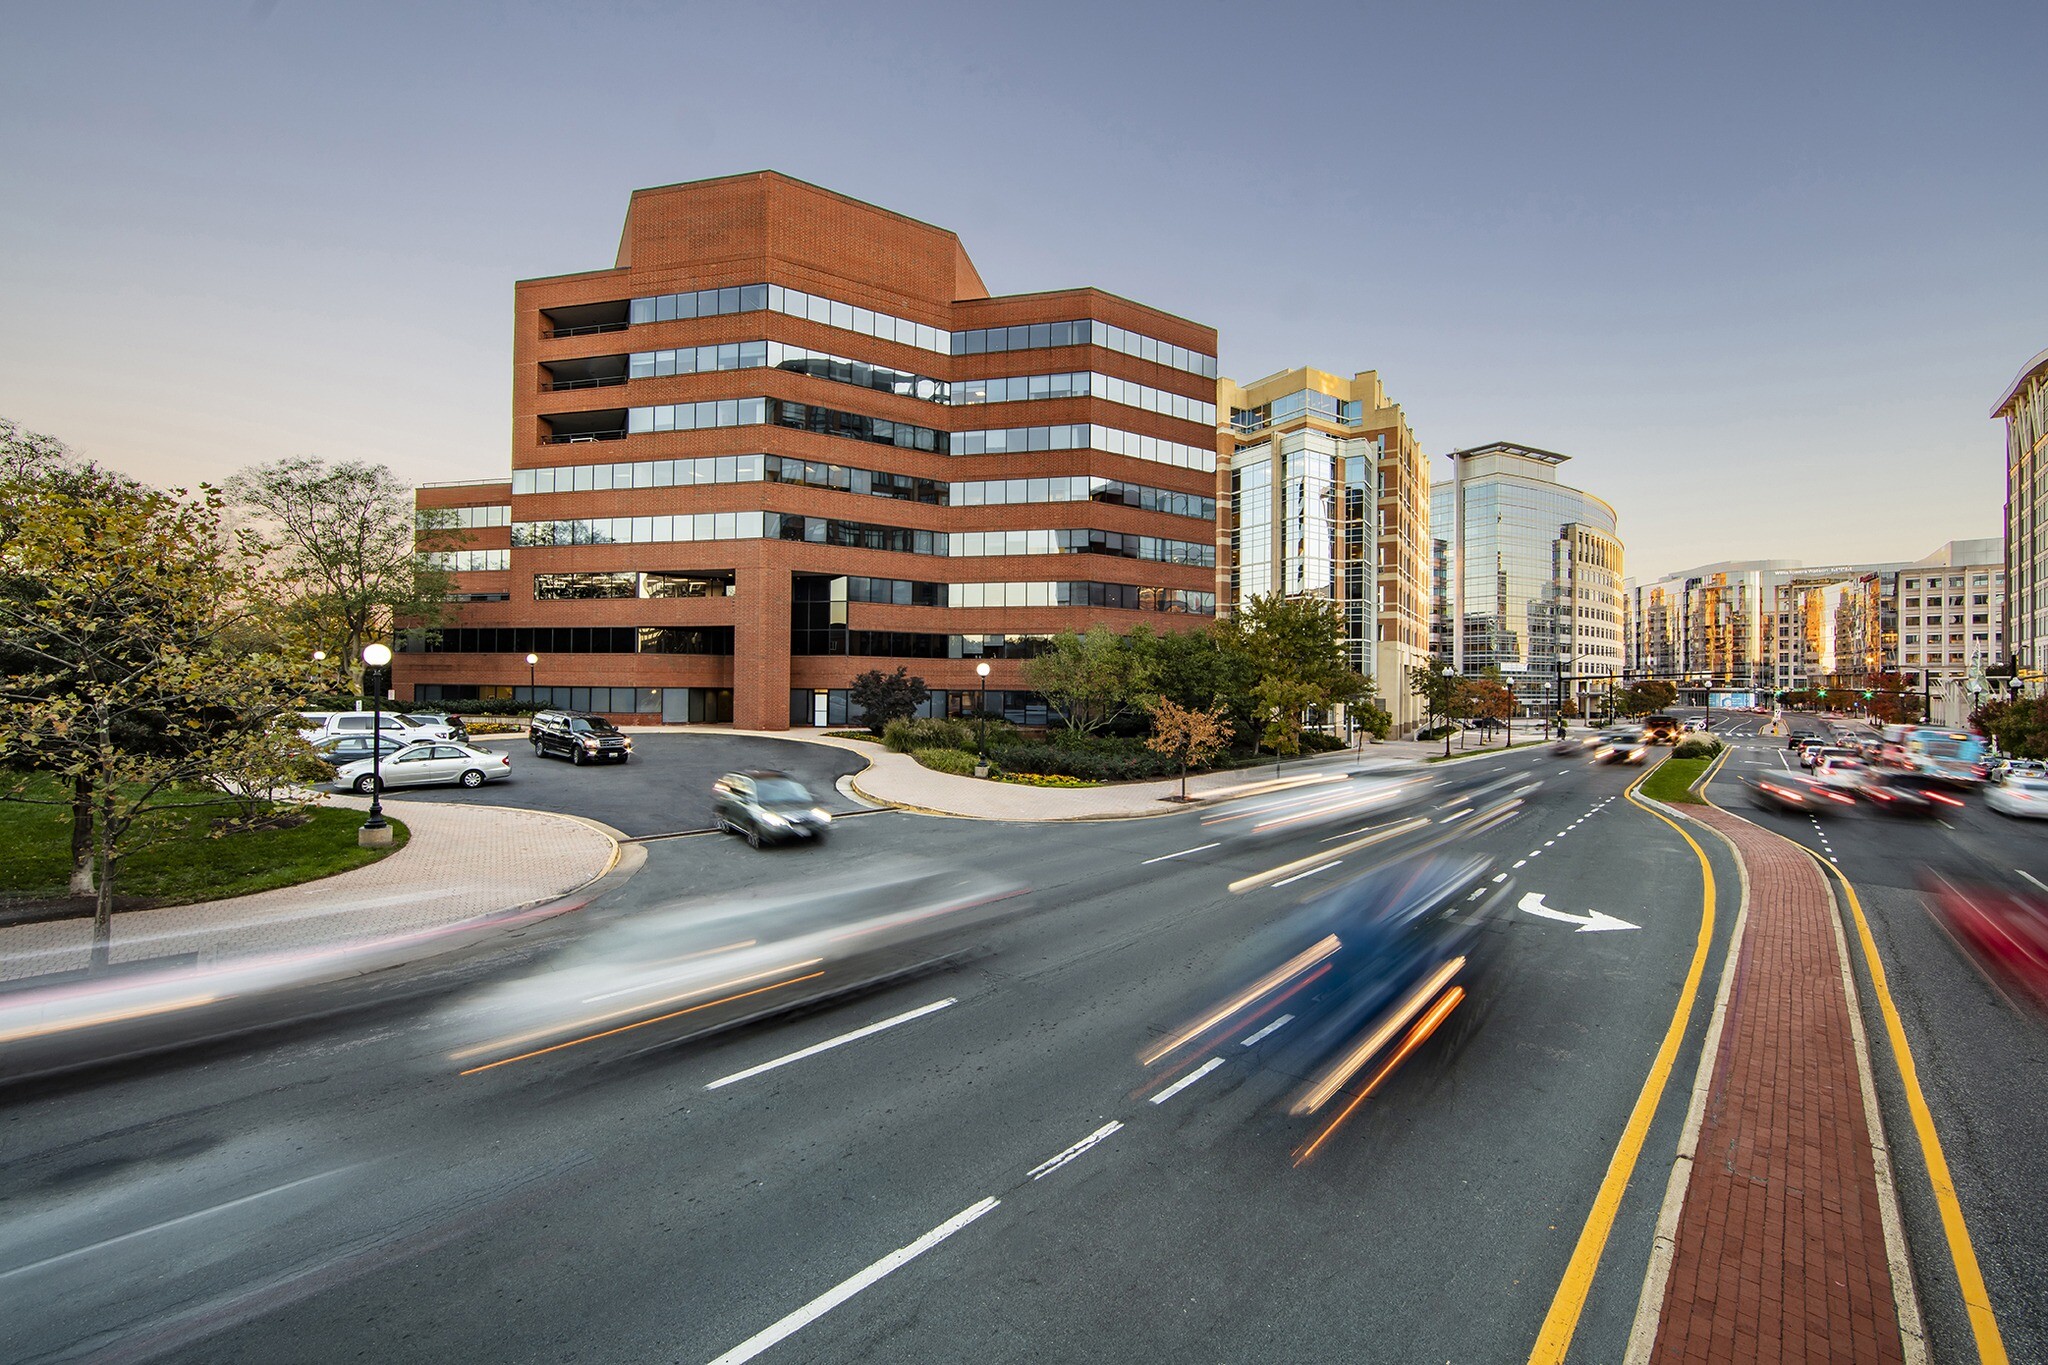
xmin=1651 ymin=806 xmax=1905 ymax=1365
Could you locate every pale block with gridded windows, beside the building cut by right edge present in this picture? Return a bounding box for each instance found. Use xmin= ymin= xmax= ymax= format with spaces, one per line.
xmin=1894 ymin=536 xmax=2007 ymax=724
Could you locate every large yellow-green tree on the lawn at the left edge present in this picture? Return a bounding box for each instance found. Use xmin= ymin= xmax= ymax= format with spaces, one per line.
xmin=0 ymin=467 xmax=305 ymax=966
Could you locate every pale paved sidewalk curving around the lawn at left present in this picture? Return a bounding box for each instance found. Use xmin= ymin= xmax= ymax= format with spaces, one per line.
xmin=0 ymin=796 xmax=618 ymax=980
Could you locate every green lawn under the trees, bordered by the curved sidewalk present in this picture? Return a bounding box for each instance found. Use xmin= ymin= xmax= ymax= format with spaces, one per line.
xmin=0 ymin=778 xmax=410 ymax=909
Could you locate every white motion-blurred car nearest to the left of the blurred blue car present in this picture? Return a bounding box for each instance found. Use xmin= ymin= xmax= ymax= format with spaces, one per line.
xmin=442 ymin=862 xmax=1026 ymax=1074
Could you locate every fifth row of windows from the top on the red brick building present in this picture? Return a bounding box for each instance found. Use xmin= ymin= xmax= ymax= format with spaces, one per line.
xmin=505 ymin=512 xmax=1217 ymax=569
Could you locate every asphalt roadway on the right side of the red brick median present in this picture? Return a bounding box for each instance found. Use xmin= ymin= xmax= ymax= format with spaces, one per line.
xmin=1710 ymin=718 xmax=2048 ymax=1361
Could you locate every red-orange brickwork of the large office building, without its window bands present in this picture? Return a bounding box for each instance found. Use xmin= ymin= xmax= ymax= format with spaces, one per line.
xmin=395 ymin=172 xmax=1217 ymax=729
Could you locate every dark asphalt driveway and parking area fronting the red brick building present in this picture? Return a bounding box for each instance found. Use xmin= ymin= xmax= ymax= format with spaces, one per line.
xmin=368 ymin=731 xmax=862 ymax=837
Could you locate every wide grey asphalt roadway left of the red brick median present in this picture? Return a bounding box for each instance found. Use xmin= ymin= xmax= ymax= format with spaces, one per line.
xmin=0 ymin=751 xmax=1737 ymax=1361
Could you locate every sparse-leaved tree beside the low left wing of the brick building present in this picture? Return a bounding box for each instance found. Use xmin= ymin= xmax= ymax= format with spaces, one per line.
xmin=227 ymin=456 xmax=467 ymax=690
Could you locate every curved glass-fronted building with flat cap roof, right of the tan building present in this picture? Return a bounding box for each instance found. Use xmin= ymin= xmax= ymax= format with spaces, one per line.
xmin=1430 ymin=442 xmax=1628 ymax=714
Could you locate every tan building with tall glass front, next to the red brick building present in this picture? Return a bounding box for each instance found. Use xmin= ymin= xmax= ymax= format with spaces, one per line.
xmin=1217 ymin=368 xmax=1430 ymax=729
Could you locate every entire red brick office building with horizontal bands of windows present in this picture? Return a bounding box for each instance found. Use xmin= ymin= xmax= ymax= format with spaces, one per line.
xmin=407 ymin=172 xmax=1217 ymax=729
